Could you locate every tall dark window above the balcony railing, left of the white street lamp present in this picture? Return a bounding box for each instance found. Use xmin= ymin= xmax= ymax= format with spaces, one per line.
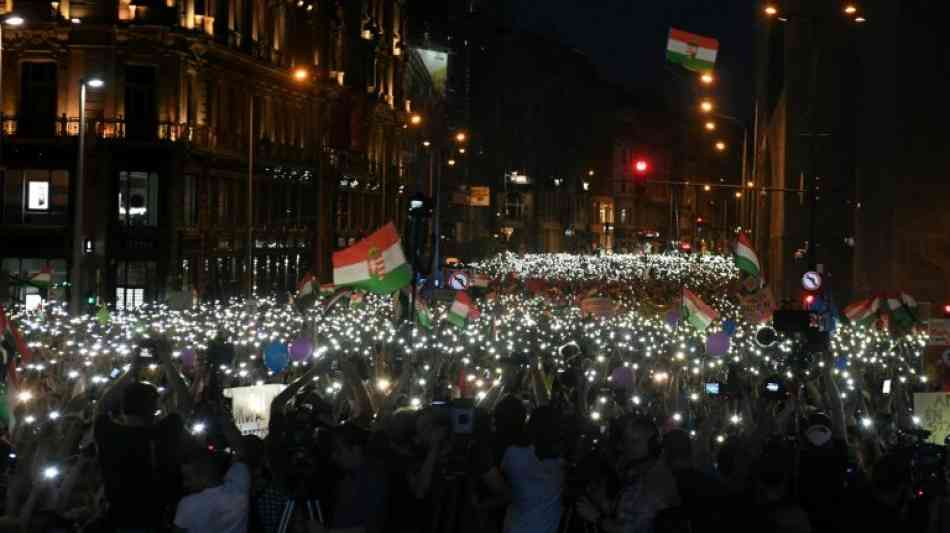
xmin=17 ymin=62 xmax=58 ymax=137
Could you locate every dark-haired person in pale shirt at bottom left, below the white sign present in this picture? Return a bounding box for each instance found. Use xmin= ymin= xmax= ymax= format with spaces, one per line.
xmin=175 ymin=452 xmax=251 ymax=533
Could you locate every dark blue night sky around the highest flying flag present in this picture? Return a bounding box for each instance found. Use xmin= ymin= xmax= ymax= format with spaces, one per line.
xmin=505 ymin=0 xmax=757 ymax=117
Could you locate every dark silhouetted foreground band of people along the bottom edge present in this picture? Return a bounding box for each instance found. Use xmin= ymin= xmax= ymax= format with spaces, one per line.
xmin=0 ymin=328 xmax=950 ymax=533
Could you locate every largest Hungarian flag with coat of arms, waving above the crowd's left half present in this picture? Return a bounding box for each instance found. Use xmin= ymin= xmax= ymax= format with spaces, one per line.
xmin=333 ymin=222 xmax=412 ymax=294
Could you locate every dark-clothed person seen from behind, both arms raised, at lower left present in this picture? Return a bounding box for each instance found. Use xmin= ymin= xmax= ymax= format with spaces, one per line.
xmin=95 ymin=338 xmax=191 ymax=532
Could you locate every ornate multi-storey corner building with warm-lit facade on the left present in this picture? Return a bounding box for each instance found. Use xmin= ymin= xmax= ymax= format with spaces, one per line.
xmin=0 ymin=0 xmax=444 ymax=308
